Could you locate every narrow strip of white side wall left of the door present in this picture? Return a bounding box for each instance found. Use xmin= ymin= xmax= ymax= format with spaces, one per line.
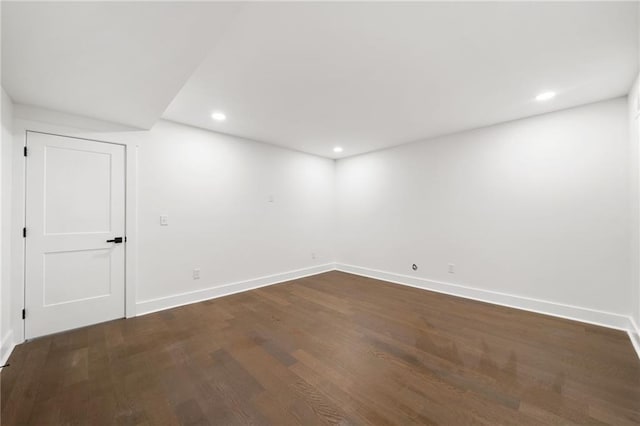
xmin=0 ymin=89 xmax=14 ymax=364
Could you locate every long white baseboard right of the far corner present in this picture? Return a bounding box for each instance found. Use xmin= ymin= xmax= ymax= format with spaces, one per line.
xmin=336 ymin=263 xmax=631 ymax=332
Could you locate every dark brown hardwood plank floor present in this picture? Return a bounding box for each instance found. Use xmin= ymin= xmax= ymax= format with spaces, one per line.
xmin=1 ymin=272 xmax=640 ymax=426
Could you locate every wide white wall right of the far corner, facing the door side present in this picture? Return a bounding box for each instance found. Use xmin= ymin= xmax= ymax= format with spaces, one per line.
xmin=336 ymin=98 xmax=632 ymax=327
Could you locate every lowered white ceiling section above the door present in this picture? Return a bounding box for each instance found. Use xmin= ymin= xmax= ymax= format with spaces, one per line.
xmin=2 ymin=1 xmax=241 ymax=128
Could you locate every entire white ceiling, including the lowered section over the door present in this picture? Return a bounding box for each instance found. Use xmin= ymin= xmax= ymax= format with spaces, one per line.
xmin=2 ymin=2 xmax=638 ymax=157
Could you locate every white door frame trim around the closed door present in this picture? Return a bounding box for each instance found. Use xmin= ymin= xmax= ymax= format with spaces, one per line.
xmin=11 ymin=117 xmax=140 ymax=343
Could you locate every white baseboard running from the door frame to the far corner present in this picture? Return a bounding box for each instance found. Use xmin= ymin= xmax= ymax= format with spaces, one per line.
xmin=136 ymin=263 xmax=335 ymax=316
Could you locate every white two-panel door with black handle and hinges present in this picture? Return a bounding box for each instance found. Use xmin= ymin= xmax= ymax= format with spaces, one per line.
xmin=25 ymin=132 xmax=125 ymax=338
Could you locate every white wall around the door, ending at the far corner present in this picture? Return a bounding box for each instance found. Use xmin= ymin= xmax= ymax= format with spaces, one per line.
xmin=12 ymin=105 xmax=335 ymax=340
